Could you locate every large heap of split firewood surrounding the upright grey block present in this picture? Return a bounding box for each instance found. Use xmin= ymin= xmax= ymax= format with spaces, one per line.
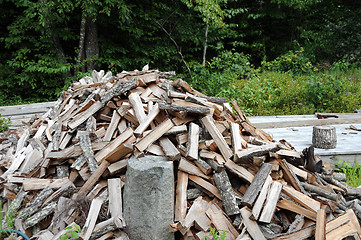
xmin=0 ymin=70 xmax=361 ymax=240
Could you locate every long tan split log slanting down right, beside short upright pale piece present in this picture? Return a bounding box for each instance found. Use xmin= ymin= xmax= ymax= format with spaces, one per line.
xmin=201 ymin=116 xmax=233 ymax=160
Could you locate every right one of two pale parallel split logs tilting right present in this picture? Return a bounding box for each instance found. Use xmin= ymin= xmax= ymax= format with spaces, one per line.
xmin=259 ymin=181 xmax=282 ymax=223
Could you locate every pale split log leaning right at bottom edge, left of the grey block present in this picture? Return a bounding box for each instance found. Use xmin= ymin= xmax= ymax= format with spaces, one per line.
xmin=79 ymin=198 xmax=104 ymax=240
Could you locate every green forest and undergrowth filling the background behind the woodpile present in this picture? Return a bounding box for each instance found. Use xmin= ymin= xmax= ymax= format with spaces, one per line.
xmin=0 ymin=0 xmax=361 ymax=115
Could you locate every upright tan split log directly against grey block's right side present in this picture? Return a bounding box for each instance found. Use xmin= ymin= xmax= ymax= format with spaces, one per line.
xmin=174 ymin=171 xmax=188 ymax=222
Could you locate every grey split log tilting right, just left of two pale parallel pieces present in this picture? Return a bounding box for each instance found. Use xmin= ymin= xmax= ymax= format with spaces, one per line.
xmin=242 ymin=163 xmax=272 ymax=207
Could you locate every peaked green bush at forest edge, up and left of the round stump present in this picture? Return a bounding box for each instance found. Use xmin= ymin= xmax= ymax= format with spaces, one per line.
xmin=262 ymin=47 xmax=318 ymax=75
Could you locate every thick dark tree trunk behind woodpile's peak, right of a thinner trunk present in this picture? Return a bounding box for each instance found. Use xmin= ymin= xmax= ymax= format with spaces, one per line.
xmin=85 ymin=17 xmax=99 ymax=72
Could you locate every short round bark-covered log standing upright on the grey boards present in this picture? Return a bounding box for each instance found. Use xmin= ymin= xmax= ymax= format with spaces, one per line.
xmin=312 ymin=126 xmax=337 ymax=149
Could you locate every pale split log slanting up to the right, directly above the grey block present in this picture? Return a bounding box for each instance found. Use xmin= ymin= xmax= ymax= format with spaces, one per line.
xmin=135 ymin=119 xmax=174 ymax=152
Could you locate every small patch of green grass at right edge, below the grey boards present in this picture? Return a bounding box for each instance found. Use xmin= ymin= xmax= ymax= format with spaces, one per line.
xmin=335 ymin=161 xmax=361 ymax=187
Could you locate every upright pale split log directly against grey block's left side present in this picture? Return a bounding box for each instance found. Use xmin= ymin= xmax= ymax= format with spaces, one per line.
xmin=108 ymin=178 xmax=123 ymax=218
